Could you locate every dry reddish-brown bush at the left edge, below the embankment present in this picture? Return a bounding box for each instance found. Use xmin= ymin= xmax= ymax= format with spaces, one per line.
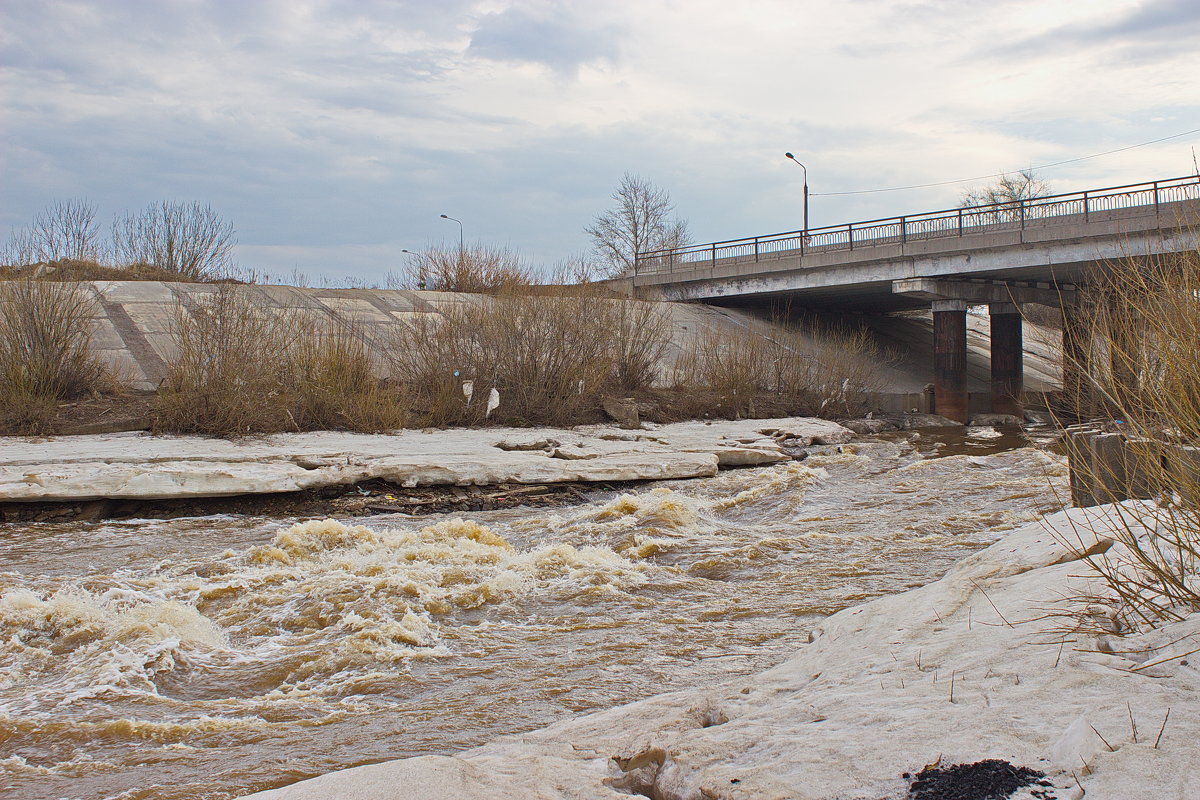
xmin=0 ymin=281 xmax=115 ymax=433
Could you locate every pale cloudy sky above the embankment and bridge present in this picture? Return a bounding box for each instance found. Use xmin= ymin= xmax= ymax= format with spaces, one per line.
xmin=0 ymin=0 xmax=1200 ymax=285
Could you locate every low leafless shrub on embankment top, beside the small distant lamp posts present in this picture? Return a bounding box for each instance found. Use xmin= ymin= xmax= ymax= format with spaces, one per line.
xmin=400 ymin=245 xmax=538 ymax=294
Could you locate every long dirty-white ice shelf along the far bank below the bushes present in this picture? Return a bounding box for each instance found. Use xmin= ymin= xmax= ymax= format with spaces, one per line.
xmin=0 ymin=417 xmax=853 ymax=501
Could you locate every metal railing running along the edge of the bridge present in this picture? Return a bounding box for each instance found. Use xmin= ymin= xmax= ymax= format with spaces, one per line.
xmin=634 ymin=175 xmax=1200 ymax=275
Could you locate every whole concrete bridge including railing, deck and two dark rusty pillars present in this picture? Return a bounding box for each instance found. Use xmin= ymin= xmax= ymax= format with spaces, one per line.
xmin=631 ymin=175 xmax=1200 ymax=421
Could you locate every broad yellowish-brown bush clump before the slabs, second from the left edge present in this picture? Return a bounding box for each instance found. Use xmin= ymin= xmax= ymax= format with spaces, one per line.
xmin=155 ymin=285 xmax=404 ymax=437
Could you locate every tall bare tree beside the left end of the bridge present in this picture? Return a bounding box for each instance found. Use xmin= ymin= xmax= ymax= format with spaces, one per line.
xmin=584 ymin=173 xmax=691 ymax=276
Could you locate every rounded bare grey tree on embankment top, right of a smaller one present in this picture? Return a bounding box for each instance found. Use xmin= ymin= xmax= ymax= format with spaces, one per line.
xmin=113 ymin=200 xmax=238 ymax=279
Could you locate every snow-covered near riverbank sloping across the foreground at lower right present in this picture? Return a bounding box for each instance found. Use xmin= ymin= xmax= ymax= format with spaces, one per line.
xmin=243 ymin=509 xmax=1200 ymax=800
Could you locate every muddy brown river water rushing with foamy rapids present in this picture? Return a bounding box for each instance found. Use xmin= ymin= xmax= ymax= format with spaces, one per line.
xmin=0 ymin=429 xmax=1066 ymax=800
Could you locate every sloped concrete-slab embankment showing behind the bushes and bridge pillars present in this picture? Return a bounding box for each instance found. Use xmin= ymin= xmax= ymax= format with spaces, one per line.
xmin=72 ymin=281 xmax=1060 ymax=393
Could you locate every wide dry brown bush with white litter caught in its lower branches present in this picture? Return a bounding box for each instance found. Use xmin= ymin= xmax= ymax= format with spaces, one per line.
xmin=389 ymin=290 xmax=667 ymax=425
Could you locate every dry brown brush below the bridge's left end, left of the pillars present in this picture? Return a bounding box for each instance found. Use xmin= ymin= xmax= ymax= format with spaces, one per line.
xmin=676 ymin=320 xmax=890 ymax=419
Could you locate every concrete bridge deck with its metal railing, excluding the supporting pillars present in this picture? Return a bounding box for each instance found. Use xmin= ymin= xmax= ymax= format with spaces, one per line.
xmin=634 ymin=176 xmax=1200 ymax=311
